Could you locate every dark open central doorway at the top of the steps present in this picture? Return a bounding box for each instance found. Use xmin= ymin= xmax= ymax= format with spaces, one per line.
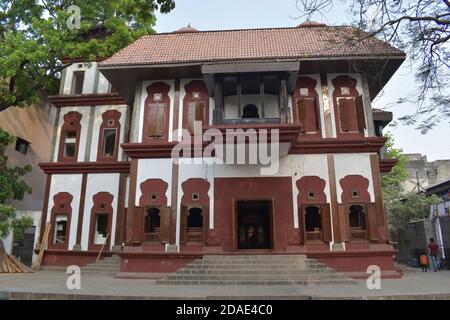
xmin=236 ymin=200 xmax=272 ymax=249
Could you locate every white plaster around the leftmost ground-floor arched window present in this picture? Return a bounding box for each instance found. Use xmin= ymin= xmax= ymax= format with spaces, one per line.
xmin=47 ymin=174 xmax=83 ymax=250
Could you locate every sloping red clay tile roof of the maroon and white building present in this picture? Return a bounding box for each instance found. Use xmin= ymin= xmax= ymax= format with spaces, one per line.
xmin=100 ymin=26 xmax=405 ymax=67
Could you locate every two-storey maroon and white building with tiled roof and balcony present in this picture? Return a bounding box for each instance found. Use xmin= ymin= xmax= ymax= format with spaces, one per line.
xmin=41 ymin=23 xmax=405 ymax=277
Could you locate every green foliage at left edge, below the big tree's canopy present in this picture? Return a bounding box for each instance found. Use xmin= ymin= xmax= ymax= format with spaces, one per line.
xmin=0 ymin=128 xmax=31 ymax=238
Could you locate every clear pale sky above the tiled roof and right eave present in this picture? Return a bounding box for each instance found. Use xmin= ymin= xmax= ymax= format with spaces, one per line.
xmin=155 ymin=0 xmax=450 ymax=161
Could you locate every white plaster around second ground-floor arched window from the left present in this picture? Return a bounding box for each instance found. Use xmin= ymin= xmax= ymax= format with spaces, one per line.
xmin=81 ymin=173 xmax=120 ymax=251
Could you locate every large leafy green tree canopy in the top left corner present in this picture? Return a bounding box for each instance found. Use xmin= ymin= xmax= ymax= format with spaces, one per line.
xmin=0 ymin=0 xmax=175 ymax=111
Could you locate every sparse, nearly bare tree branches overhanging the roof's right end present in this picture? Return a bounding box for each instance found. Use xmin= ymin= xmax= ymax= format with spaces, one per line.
xmin=296 ymin=0 xmax=450 ymax=133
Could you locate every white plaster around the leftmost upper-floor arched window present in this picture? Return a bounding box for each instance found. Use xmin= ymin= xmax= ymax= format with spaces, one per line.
xmin=53 ymin=107 xmax=91 ymax=162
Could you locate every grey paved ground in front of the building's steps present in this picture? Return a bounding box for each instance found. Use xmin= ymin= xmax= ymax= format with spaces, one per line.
xmin=0 ymin=270 xmax=450 ymax=300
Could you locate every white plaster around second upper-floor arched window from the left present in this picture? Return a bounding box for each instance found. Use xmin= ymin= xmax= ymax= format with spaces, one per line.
xmin=89 ymin=105 xmax=127 ymax=161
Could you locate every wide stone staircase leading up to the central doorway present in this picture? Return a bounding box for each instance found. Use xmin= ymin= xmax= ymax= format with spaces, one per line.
xmin=157 ymin=255 xmax=356 ymax=285
